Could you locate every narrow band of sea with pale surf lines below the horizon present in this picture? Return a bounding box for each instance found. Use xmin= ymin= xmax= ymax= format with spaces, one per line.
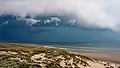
xmin=6 ymin=42 xmax=120 ymax=52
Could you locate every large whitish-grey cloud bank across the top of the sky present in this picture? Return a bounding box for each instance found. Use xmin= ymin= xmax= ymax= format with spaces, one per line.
xmin=0 ymin=0 xmax=120 ymax=31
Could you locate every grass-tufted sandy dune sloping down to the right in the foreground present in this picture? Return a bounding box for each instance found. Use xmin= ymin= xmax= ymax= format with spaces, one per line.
xmin=0 ymin=43 xmax=119 ymax=68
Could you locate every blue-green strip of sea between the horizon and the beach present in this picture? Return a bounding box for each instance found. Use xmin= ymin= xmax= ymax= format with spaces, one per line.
xmin=35 ymin=42 xmax=120 ymax=51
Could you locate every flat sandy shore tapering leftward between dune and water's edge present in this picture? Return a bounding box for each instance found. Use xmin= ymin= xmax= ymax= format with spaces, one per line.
xmin=44 ymin=46 xmax=120 ymax=64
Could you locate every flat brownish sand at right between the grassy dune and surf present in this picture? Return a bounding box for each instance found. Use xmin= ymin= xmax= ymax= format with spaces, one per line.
xmin=65 ymin=49 xmax=120 ymax=63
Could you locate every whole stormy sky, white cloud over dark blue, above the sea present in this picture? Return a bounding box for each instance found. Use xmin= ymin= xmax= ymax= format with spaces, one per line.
xmin=0 ymin=0 xmax=120 ymax=42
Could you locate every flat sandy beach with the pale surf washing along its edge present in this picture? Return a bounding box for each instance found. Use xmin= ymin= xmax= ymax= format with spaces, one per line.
xmin=3 ymin=43 xmax=120 ymax=64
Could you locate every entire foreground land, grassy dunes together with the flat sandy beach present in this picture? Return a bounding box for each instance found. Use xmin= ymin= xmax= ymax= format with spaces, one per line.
xmin=0 ymin=43 xmax=120 ymax=68
